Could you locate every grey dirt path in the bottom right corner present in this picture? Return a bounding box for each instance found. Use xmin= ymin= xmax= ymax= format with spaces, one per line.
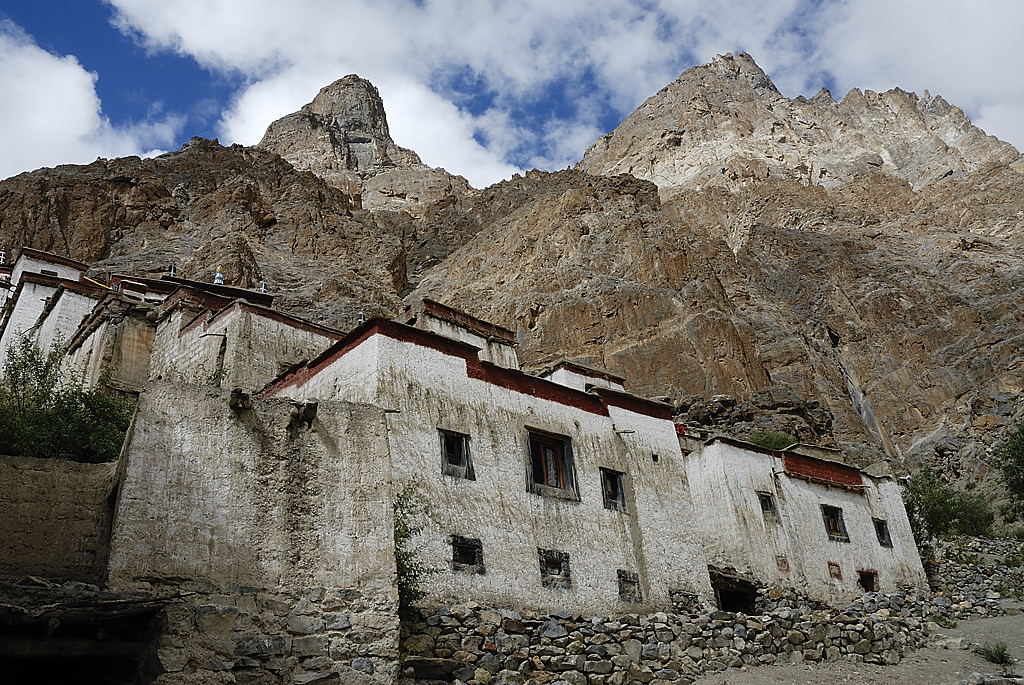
xmin=696 ymin=605 xmax=1024 ymax=685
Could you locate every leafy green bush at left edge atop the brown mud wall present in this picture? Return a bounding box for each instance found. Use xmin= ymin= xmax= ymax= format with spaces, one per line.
xmin=0 ymin=338 xmax=133 ymax=463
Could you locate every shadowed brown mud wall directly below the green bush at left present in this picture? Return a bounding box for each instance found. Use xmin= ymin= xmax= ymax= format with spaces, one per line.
xmin=0 ymin=457 xmax=117 ymax=582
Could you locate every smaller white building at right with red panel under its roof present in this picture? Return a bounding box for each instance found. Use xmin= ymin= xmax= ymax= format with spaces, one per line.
xmin=680 ymin=436 xmax=928 ymax=604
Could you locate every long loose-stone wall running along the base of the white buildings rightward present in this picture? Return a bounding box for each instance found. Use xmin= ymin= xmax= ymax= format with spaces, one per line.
xmin=399 ymin=539 xmax=1024 ymax=685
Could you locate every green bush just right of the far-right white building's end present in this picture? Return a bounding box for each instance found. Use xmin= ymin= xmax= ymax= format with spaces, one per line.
xmin=903 ymin=468 xmax=994 ymax=545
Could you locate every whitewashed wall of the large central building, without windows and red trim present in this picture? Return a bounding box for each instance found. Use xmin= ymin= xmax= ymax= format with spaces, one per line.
xmin=280 ymin=327 xmax=711 ymax=612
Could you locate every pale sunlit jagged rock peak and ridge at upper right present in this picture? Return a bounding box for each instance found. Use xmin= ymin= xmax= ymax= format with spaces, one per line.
xmin=578 ymin=53 xmax=1024 ymax=205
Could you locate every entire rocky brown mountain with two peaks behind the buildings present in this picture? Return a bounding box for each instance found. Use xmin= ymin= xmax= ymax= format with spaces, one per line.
xmin=0 ymin=54 xmax=1024 ymax=491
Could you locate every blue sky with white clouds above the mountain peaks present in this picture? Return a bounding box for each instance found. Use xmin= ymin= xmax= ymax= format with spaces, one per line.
xmin=0 ymin=0 xmax=1024 ymax=187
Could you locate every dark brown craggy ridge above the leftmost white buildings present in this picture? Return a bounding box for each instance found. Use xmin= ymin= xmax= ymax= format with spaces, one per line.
xmin=0 ymin=138 xmax=408 ymax=326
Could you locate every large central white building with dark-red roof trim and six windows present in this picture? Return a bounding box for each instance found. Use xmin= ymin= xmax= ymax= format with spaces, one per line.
xmin=263 ymin=301 xmax=711 ymax=612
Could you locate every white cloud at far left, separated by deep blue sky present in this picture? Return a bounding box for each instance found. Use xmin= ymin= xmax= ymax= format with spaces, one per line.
xmin=0 ymin=22 xmax=179 ymax=178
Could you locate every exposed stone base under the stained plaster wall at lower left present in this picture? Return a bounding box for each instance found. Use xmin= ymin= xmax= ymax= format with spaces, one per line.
xmin=156 ymin=584 xmax=398 ymax=685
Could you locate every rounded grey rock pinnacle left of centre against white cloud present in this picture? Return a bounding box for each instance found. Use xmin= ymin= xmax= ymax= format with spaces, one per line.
xmin=256 ymin=74 xmax=469 ymax=214
